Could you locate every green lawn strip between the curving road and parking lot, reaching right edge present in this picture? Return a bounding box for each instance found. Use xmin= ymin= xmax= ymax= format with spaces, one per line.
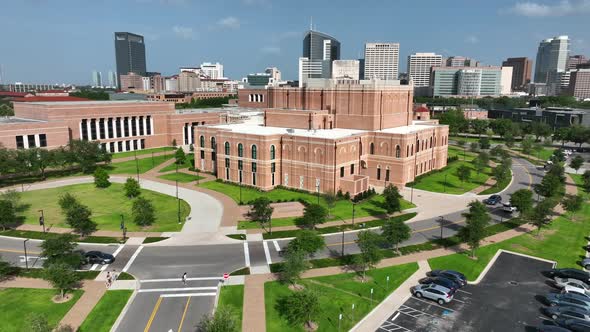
xmin=428 ymin=177 xmax=590 ymax=280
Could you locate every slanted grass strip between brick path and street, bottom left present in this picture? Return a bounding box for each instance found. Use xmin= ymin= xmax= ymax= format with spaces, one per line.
xmin=78 ymin=290 xmax=133 ymax=332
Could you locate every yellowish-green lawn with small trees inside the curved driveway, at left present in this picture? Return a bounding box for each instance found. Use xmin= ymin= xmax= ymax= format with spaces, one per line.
xmin=21 ymin=183 xmax=190 ymax=232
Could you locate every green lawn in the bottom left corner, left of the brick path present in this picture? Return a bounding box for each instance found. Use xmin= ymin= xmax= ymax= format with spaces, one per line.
xmin=0 ymin=288 xmax=84 ymax=332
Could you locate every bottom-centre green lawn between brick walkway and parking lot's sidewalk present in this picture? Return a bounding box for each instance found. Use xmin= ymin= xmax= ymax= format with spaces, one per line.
xmin=264 ymin=263 xmax=418 ymax=331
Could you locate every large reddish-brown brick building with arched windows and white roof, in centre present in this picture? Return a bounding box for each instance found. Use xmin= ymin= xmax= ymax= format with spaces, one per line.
xmin=195 ymin=80 xmax=448 ymax=195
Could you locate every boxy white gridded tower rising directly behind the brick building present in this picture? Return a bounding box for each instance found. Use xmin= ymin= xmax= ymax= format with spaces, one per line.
xmin=366 ymin=43 xmax=399 ymax=80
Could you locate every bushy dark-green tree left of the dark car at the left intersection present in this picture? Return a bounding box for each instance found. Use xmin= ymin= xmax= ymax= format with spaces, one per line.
xmin=41 ymin=234 xmax=82 ymax=268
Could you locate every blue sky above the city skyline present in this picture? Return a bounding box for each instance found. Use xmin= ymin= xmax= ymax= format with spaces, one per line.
xmin=0 ymin=0 xmax=590 ymax=84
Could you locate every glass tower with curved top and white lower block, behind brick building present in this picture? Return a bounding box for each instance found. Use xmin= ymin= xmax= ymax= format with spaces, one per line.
xmin=299 ymin=30 xmax=340 ymax=86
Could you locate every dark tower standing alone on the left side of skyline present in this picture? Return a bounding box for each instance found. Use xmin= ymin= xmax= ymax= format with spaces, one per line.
xmin=115 ymin=32 xmax=147 ymax=86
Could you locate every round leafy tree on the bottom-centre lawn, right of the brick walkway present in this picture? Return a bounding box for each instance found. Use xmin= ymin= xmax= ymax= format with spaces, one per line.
xmin=277 ymin=290 xmax=322 ymax=329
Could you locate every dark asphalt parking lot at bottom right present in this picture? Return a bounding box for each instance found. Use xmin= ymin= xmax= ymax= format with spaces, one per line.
xmin=377 ymin=252 xmax=554 ymax=332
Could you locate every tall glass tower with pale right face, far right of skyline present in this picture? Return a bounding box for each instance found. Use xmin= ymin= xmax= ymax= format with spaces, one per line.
xmin=535 ymin=36 xmax=570 ymax=83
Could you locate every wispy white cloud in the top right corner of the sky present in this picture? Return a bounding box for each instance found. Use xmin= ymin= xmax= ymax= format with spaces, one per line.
xmin=504 ymin=0 xmax=590 ymax=17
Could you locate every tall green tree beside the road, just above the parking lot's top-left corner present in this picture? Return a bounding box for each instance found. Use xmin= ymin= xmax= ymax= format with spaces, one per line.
xmin=459 ymin=201 xmax=491 ymax=257
